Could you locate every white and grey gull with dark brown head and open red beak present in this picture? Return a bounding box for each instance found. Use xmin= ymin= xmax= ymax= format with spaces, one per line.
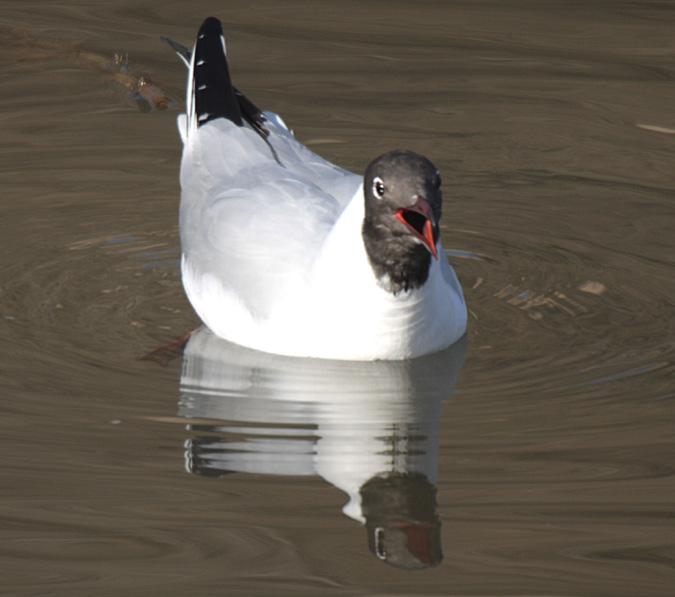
xmin=163 ymin=17 xmax=467 ymax=361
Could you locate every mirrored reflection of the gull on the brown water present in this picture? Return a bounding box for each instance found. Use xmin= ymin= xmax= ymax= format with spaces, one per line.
xmin=179 ymin=328 xmax=467 ymax=569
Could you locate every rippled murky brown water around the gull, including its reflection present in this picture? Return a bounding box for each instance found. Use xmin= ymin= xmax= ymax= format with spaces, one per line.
xmin=0 ymin=0 xmax=675 ymax=596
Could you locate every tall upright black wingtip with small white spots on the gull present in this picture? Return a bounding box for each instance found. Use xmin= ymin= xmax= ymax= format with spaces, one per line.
xmin=192 ymin=17 xmax=243 ymax=126
